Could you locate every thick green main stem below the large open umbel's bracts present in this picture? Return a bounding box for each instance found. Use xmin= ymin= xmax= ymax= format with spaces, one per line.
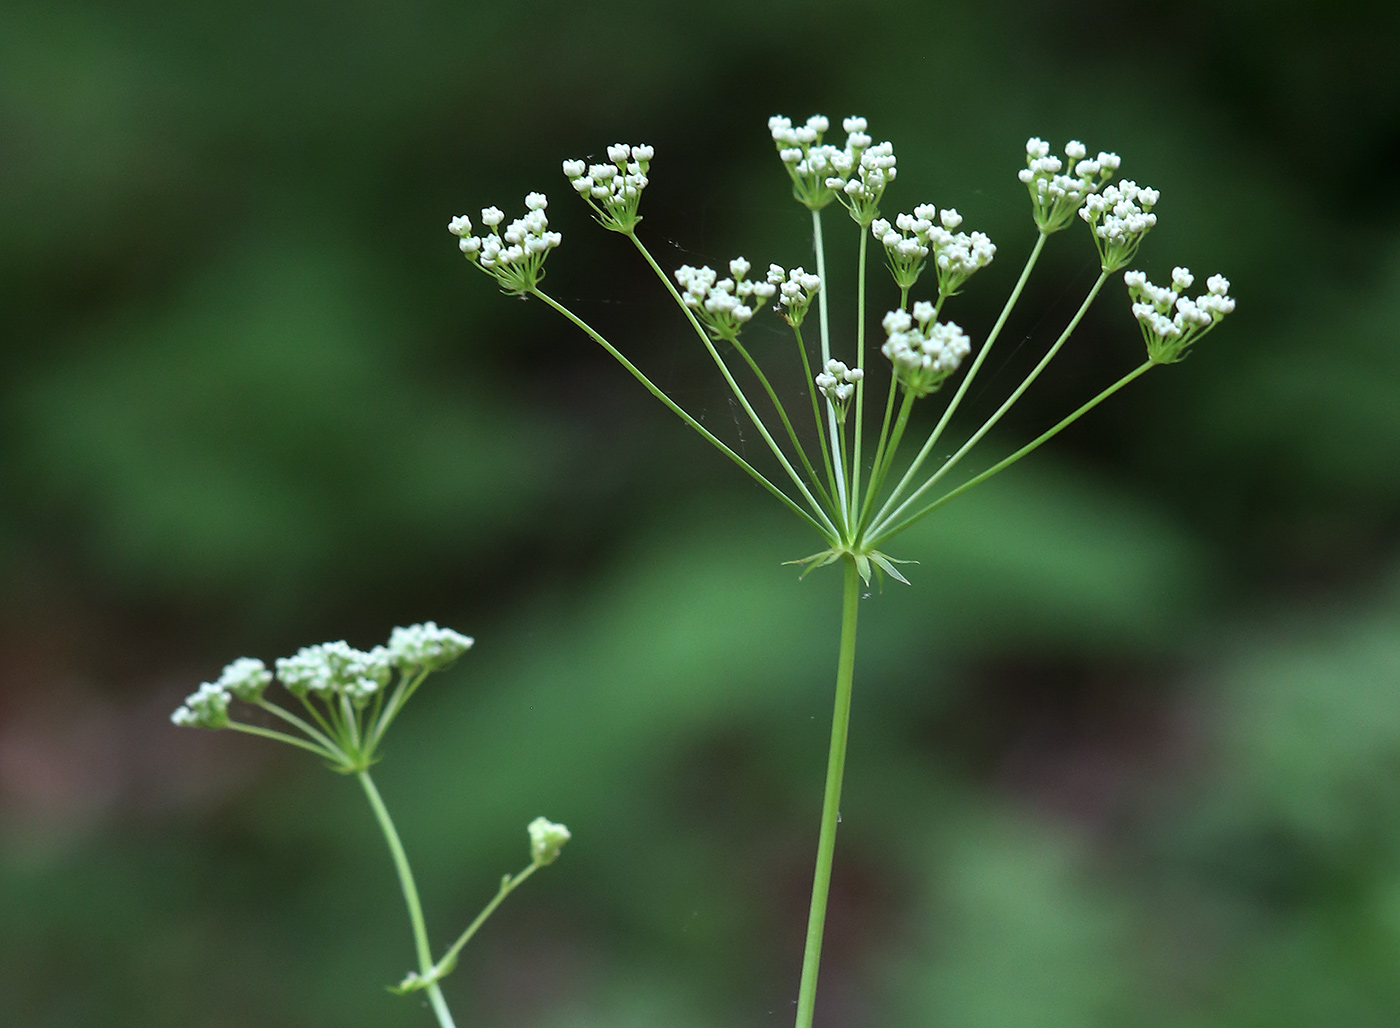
xmin=797 ymin=555 xmax=861 ymax=1028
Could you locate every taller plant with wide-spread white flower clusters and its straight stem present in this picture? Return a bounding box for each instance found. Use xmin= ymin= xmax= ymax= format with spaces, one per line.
xmin=448 ymin=115 xmax=1235 ymax=1028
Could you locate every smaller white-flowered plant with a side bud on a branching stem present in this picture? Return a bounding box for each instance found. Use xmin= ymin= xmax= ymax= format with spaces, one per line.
xmin=171 ymin=622 xmax=568 ymax=1028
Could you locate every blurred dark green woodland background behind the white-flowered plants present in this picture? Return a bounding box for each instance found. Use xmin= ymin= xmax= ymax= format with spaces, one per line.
xmin=0 ymin=0 xmax=1400 ymax=1028
